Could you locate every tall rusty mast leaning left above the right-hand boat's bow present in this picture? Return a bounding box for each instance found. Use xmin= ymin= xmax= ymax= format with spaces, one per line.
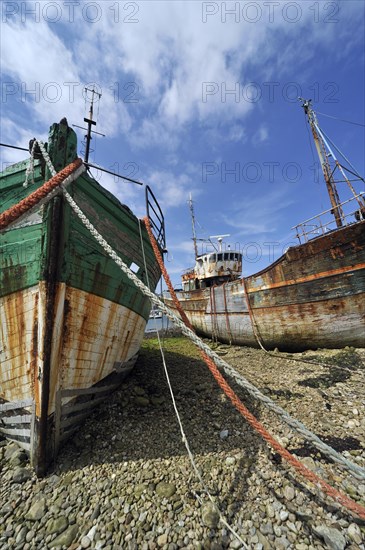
xmin=299 ymin=98 xmax=345 ymax=227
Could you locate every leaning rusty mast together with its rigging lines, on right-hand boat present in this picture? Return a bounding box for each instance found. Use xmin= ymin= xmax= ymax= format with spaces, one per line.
xmin=298 ymin=97 xmax=365 ymax=227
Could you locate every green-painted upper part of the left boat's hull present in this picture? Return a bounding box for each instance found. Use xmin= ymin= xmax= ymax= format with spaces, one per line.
xmin=0 ymin=125 xmax=160 ymax=320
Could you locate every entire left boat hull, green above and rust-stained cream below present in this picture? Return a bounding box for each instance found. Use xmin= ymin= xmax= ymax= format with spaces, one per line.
xmin=0 ymin=124 xmax=160 ymax=475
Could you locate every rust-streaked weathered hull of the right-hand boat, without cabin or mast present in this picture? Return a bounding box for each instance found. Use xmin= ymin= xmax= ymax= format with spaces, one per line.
xmin=166 ymin=221 xmax=365 ymax=351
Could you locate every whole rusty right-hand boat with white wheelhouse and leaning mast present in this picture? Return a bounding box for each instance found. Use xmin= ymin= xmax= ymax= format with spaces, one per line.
xmin=165 ymin=100 xmax=365 ymax=351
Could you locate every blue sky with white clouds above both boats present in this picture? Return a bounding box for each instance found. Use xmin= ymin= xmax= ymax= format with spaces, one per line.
xmin=0 ymin=0 xmax=365 ymax=285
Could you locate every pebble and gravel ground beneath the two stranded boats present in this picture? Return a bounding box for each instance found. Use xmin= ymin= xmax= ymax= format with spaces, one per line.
xmin=0 ymin=337 xmax=365 ymax=550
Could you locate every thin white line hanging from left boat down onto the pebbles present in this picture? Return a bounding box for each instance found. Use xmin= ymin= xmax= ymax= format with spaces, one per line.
xmin=138 ymin=223 xmax=248 ymax=549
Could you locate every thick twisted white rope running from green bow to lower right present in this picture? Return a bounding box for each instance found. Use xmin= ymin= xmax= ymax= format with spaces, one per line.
xmin=61 ymin=184 xmax=365 ymax=480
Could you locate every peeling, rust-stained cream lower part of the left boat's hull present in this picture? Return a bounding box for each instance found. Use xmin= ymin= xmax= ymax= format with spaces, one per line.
xmin=0 ymin=283 xmax=150 ymax=469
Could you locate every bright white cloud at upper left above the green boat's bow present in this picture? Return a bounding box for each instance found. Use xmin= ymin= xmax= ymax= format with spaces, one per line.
xmin=1 ymin=19 xmax=132 ymax=144
